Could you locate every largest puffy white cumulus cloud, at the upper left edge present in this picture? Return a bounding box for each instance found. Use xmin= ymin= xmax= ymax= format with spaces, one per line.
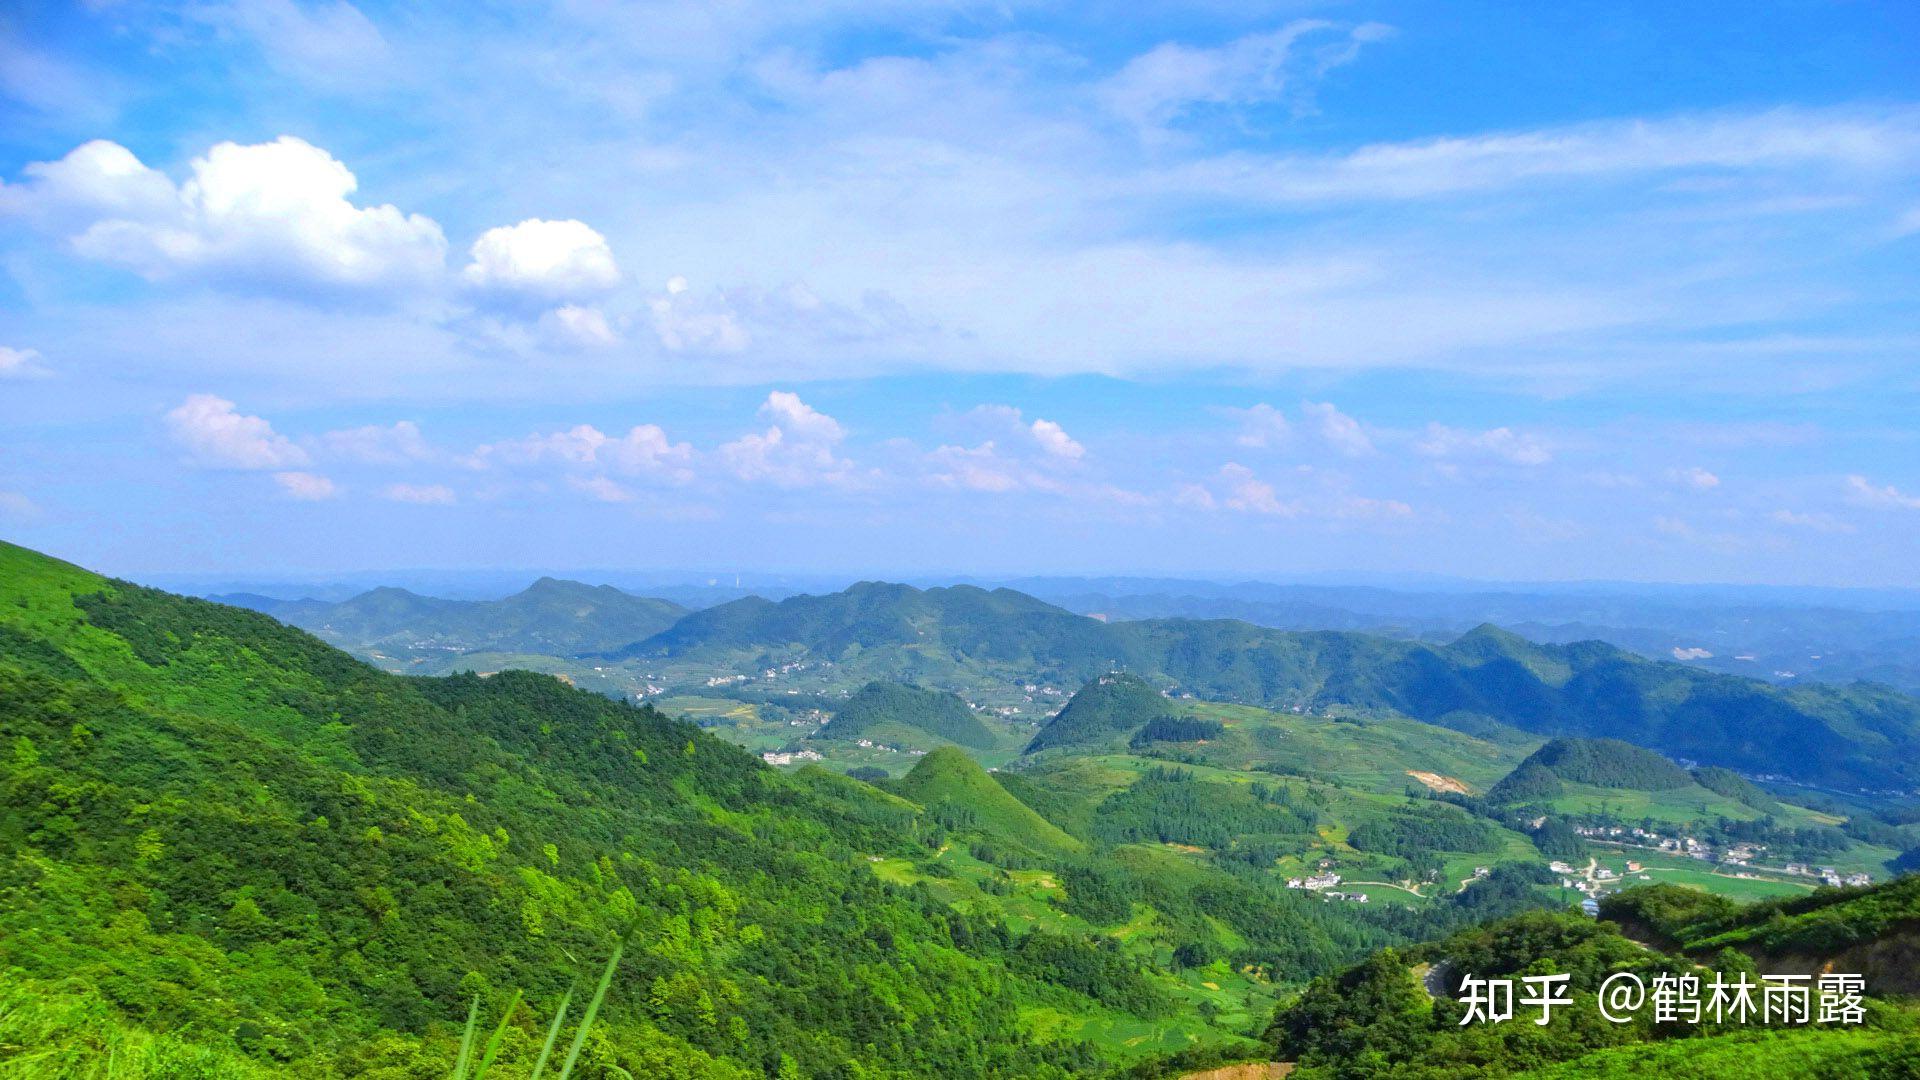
xmin=8 ymin=135 xmax=445 ymax=288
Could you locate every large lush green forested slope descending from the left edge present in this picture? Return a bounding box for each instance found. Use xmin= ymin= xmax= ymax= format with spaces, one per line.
xmin=0 ymin=548 xmax=1228 ymax=1078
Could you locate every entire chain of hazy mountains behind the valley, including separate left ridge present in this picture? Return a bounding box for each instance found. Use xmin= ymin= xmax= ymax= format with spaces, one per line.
xmin=202 ymin=578 xmax=1920 ymax=790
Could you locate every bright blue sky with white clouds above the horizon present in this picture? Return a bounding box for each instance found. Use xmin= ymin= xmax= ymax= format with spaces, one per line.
xmin=0 ymin=0 xmax=1920 ymax=586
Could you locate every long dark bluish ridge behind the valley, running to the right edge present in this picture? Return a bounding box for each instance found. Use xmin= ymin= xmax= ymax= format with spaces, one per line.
xmin=609 ymin=582 xmax=1920 ymax=790
